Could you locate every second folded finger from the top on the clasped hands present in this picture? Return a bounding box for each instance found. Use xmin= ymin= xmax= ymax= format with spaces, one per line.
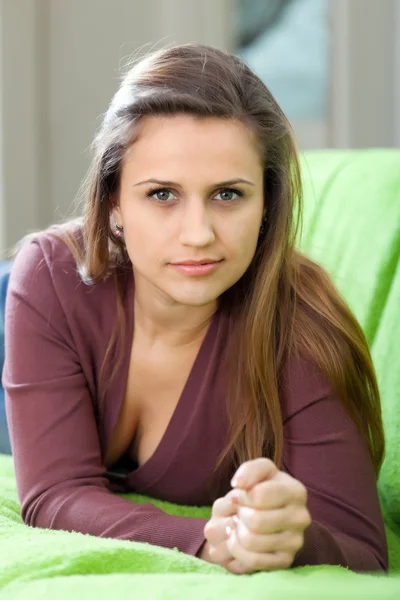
xmin=237 ymin=505 xmax=311 ymax=534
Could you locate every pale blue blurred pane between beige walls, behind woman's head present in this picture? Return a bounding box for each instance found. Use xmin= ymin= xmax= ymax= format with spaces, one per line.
xmin=238 ymin=0 xmax=330 ymax=119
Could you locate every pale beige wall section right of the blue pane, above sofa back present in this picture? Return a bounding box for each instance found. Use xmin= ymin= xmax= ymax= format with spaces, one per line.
xmin=328 ymin=0 xmax=400 ymax=148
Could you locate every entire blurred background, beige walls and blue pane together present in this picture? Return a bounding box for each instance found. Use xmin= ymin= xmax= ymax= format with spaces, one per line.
xmin=0 ymin=0 xmax=400 ymax=254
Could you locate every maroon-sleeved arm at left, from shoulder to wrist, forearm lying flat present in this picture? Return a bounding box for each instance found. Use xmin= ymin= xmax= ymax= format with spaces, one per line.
xmin=3 ymin=238 xmax=207 ymax=555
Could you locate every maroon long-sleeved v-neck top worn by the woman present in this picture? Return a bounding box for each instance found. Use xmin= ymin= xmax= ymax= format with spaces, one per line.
xmin=3 ymin=232 xmax=388 ymax=571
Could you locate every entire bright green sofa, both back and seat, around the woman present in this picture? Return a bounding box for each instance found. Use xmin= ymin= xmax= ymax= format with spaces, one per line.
xmin=0 ymin=149 xmax=400 ymax=600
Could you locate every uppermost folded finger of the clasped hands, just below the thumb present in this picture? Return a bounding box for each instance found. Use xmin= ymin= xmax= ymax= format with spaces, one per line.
xmin=233 ymin=473 xmax=307 ymax=510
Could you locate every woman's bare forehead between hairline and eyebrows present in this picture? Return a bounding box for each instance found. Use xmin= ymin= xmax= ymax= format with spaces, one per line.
xmin=124 ymin=114 xmax=262 ymax=178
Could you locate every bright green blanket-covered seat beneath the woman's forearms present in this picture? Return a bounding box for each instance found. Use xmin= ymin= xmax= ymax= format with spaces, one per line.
xmin=0 ymin=455 xmax=400 ymax=600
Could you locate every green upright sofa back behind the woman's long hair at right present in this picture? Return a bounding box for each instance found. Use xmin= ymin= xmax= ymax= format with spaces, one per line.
xmin=300 ymin=149 xmax=400 ymax=525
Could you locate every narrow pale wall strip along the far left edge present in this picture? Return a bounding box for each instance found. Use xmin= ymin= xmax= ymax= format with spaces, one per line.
xmin=0 ymin=0 xmax=46 ymax=255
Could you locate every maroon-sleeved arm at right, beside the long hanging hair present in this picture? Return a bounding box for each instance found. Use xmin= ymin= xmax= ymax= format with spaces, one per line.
xmin=282 ymin=361 xmax=388 ymax=571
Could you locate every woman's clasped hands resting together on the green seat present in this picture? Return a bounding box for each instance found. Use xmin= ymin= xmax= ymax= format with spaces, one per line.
xmin=200 ymin=458 xmax=311 ymax=574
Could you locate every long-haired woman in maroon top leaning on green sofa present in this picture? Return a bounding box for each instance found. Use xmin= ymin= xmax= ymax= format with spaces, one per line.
xmin=3 ymin=44 xmax=388 ymax=573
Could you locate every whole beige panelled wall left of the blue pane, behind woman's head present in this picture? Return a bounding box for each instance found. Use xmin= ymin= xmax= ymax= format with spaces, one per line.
xmin=0 ymin=0 xmax=233 ymax=251
